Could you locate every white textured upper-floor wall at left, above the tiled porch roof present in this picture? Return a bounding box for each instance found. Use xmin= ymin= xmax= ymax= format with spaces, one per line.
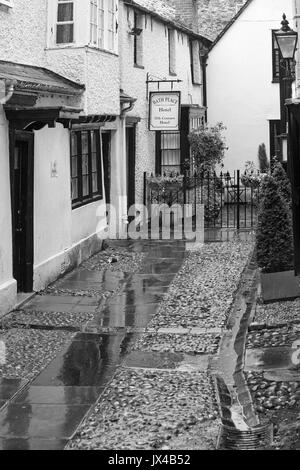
xmin=0 ymin=0 xmax=120 ymax=114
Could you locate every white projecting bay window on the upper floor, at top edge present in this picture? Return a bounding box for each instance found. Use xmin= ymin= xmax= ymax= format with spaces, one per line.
xmin=90 ymin=0 xmax=118 ymax=51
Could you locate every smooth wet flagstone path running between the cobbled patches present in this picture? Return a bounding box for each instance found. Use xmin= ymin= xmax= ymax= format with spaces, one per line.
xmin=0 ymin=242 xmax=188 ymax=450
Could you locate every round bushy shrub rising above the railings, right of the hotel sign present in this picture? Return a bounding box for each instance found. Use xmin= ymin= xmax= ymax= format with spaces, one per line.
xmin=188 ymin=123 xmax=226 ymax=173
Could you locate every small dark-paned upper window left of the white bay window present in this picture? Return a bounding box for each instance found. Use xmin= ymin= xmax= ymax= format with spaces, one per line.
xmin=56 ymin=0 xmax=74 ymax=44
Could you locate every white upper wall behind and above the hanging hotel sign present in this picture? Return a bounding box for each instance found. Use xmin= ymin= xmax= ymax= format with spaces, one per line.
xmin=119 ymin=2 xmax=203 ymax=203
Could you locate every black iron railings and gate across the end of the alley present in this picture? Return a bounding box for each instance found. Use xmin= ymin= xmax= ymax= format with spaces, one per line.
xmin=144 ymin=170 xmax=259 ymax=230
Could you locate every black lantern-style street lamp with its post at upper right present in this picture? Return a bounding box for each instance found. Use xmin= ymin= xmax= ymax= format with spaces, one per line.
xmin=274 ymin=13 xmax=298 ymax=164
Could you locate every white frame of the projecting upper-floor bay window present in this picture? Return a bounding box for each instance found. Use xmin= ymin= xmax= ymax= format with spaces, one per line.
xmin=89 ymin=0 xmax=119 ymax=53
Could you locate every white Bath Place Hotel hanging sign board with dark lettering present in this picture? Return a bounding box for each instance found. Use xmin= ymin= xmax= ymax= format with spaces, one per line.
xmin=149 ymin=91 xmax=181 ymax=131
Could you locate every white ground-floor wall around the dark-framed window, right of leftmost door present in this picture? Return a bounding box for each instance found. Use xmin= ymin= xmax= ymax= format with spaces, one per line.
xmin=34 ymin=124 xmax=106 ymax=291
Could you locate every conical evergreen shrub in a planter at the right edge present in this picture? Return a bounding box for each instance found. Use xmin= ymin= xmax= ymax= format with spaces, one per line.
xmin=256 ymin=176 xmax=294 ymax=273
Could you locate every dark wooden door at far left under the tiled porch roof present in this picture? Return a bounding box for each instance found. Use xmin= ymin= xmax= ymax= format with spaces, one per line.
xmin=10 ymin=131 xmax=34 ymax=292
